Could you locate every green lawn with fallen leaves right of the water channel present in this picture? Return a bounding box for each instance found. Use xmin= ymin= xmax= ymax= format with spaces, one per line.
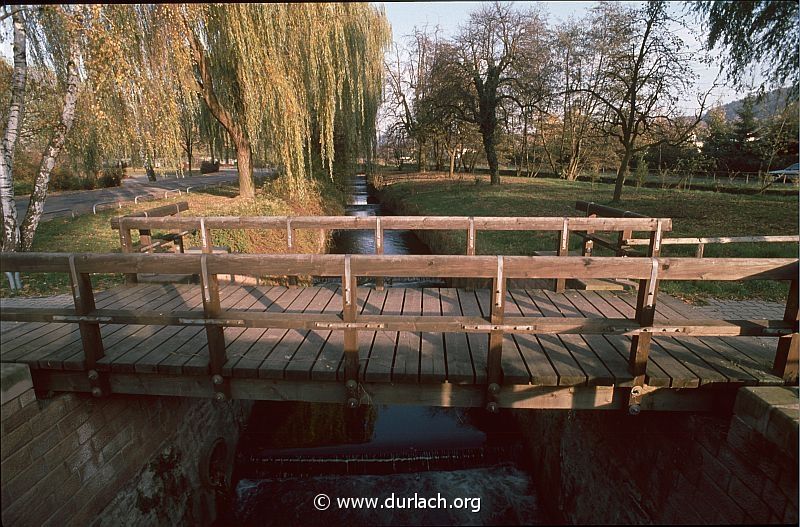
xmin=381 ymin=175 xmax=798 ymax=302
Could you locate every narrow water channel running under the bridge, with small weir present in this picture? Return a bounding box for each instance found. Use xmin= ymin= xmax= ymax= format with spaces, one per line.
xmin=217 ymin=175 xmax=546 ymax=526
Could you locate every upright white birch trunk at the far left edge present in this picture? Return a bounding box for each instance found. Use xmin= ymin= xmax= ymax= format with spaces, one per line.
xmin=0 ymin=7 xmax=28 ymax=251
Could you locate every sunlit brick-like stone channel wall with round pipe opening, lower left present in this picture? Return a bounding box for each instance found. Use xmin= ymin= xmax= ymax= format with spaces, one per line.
xmin=0 ymin=364 xmax=250 ymax=526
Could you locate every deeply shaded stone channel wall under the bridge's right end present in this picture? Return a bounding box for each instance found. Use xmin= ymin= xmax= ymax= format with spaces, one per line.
xmin=515 ymin=387 xmax=798 ymax=524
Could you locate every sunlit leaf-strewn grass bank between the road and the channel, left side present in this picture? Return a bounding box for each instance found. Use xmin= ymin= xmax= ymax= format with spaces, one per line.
xmin=0 ymin=177 xmax=343 ymax=297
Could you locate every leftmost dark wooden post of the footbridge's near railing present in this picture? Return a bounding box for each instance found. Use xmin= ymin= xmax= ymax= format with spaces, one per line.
xmin=69 ymin=255 xmax=111 ymax=397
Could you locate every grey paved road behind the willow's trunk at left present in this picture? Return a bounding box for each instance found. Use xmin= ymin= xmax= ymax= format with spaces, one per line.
xmin=17 ymin=169 xmax=265 ymax=221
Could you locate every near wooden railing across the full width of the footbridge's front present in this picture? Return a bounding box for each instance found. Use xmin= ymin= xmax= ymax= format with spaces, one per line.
xmin=0 ymin=252 xmax=798 ymax=409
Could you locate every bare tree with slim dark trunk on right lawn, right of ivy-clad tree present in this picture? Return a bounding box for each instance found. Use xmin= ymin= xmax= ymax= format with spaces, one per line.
xmin=580 ymin=1 xmax=711 ymax=201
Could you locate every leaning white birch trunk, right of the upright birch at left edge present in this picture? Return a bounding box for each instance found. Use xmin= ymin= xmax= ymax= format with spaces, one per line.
xmin=19 ymin=42 xmax=78 ymax=251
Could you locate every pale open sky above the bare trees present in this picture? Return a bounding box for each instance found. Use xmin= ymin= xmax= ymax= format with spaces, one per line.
xmin=383 ymin=1 xmax=745 ymax=113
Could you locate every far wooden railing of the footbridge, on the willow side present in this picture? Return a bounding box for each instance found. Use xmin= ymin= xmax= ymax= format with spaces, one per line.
xmin=111 ymin=216 xmax=672 ymax=292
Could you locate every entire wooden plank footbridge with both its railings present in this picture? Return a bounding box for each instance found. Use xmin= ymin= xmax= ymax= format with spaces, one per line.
xmin=0 ymin=213 xmax=798 ymax=413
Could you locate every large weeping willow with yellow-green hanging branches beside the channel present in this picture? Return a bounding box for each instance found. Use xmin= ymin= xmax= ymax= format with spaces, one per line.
xmin=86 ymin=3 xmax=391 ymax=197
